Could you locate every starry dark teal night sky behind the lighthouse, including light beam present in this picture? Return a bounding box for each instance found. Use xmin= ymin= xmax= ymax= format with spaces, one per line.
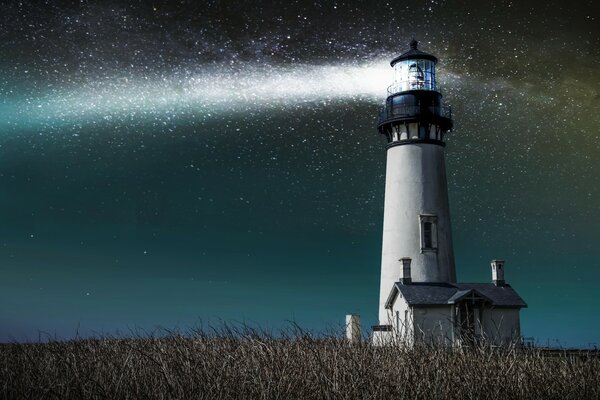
xmin=0 ymin=0 xmax=600 ymax=346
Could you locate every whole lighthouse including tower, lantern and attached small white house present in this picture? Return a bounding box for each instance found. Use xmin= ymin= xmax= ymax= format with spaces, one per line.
xmin=372 ymin=40 xmax=527 ymax=346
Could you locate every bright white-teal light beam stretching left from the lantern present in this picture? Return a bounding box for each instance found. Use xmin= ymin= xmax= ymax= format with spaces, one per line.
xmin=0 ymin=58 xmax=400 ymax=127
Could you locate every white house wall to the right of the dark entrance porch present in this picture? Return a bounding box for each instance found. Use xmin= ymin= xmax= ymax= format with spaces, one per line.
xmin=481 ymin=308 xmax=521 ymax=346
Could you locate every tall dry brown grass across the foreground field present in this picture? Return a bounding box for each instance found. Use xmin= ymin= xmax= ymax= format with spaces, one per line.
xmin=0 ymin=327 xmax=600 ymax=400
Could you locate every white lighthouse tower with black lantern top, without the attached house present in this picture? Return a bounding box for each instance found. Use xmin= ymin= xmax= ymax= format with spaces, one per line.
xmin=379 ymin=40 xmax=456 ymax=325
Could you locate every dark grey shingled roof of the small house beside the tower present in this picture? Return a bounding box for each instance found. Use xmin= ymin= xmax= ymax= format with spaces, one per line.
xmin=385 ymin=282 xmax=527 ymax=308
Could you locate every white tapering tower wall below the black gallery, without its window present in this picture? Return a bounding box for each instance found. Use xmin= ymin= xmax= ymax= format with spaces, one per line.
xmin=379 ymin=143 xmax=456 ymax=323
